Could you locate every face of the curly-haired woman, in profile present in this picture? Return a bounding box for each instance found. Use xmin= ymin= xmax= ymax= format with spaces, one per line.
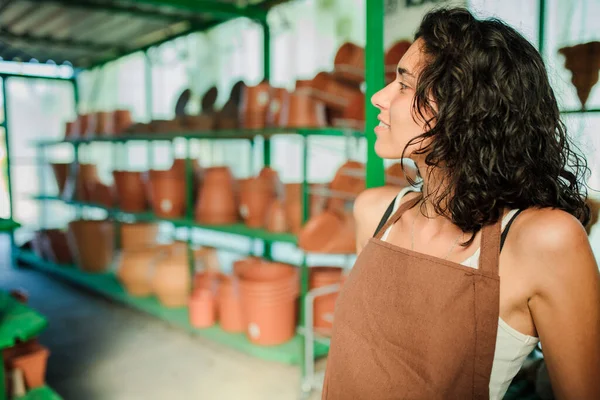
xmin=371 ymin=39 xmax=427 ymax=159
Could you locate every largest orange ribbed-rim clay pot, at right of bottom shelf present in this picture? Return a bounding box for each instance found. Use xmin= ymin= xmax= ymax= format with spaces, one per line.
xmin=240 ymin=263 xmax=299 ymax=346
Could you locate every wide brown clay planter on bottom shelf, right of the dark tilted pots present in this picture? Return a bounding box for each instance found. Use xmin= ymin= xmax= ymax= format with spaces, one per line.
xmin=68 ymin=220 xmax=114 ymax=273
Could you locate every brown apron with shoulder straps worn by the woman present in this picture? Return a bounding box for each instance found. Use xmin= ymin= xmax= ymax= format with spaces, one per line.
xmin=322 ymin=197 xmax=501 ymax=400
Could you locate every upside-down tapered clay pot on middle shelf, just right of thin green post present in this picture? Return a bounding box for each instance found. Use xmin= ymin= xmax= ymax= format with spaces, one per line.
xmin=195 ymin=167 xmax=238 ymax=225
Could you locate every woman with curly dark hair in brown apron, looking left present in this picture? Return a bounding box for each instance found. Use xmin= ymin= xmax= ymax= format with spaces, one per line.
xmin=323 ymin=9 xmax=600 ymax=400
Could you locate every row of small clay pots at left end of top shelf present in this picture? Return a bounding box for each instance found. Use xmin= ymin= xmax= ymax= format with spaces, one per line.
xmin=65 ymin=110 xmax=132 ymax=140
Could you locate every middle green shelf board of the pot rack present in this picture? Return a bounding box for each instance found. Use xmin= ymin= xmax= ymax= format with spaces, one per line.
xmin=33 ymin=196 xmax=298 ymax=244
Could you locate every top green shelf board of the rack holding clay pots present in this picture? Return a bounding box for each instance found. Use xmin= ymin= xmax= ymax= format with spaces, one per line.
xmin=35 ymin=128 xmax=364 ymax=146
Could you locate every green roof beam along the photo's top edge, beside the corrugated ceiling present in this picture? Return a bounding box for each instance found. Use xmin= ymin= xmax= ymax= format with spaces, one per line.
xmin=137 ymin=0 xmax=267 ymax=21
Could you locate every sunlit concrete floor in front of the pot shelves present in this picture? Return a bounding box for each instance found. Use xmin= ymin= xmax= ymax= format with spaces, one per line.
xmin=0 ymin=235 xmax=320 ymax=400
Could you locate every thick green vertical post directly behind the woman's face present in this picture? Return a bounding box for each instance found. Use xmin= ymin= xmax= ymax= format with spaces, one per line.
xmin=365 ymin=0 xmax=385 ymax=188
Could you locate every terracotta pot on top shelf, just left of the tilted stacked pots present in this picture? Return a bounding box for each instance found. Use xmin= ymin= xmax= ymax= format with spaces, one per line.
xmin=280 ymin=89 xmax=327 ymax=128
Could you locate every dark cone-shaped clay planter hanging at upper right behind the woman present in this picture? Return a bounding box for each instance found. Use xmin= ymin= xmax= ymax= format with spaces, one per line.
xmin=558 ymin=42 xmax=600 ymax=108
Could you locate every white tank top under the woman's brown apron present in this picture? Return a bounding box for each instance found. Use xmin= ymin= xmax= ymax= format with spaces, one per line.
xmin=381 ymin=186 xmax=539 ymax=400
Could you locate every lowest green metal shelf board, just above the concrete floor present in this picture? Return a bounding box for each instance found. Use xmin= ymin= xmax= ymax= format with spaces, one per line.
xmin=17 ymin=250 xmax=329 ymax=365
